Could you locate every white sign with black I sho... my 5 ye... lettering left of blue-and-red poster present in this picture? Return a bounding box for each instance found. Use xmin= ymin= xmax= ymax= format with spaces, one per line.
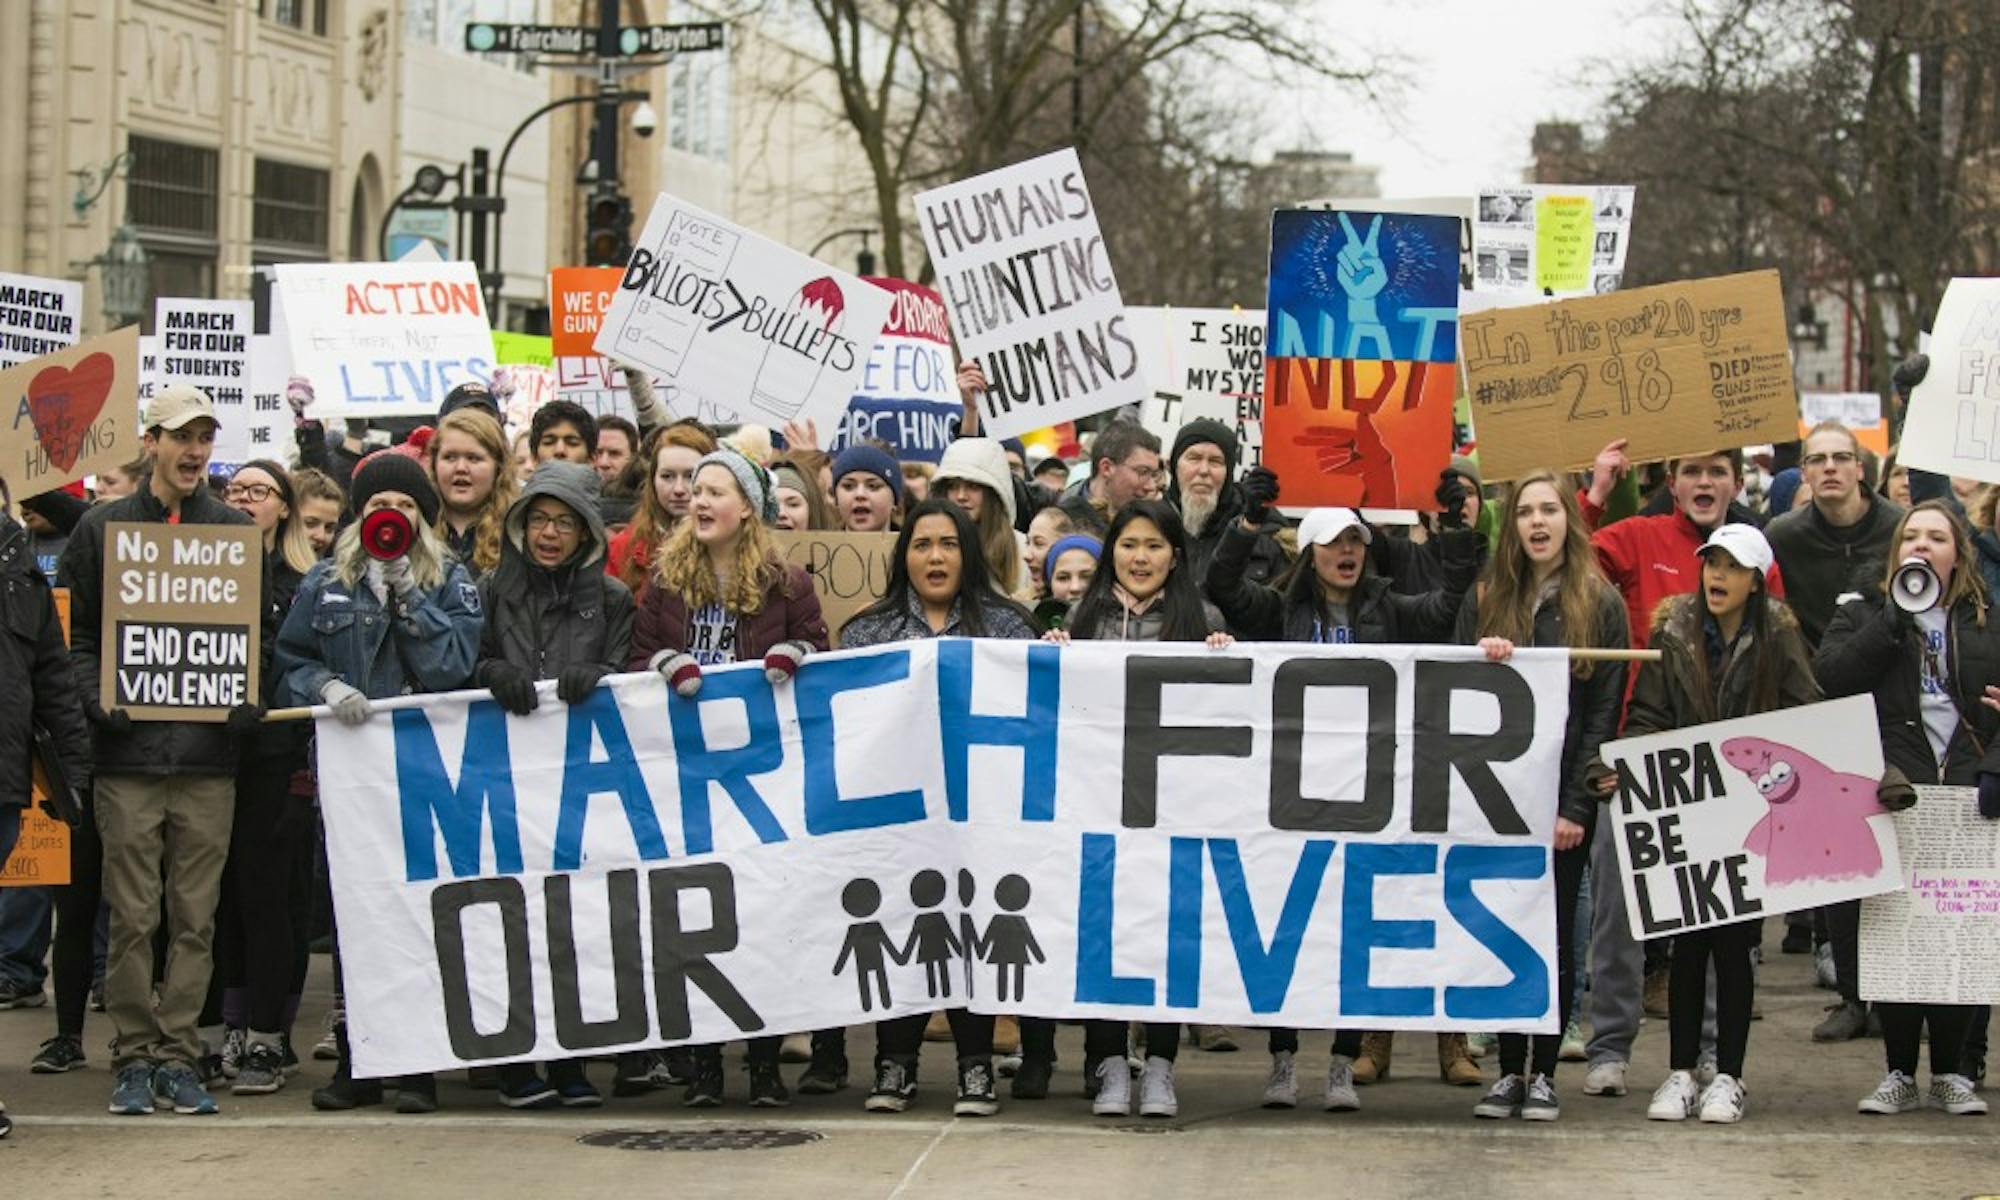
xmin=1126 ymin=308 xmax=1264 ymax=470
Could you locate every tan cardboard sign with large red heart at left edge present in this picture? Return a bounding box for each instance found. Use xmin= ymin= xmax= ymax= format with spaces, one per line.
xmin=0 ymin=326 xmax=140 ymax=500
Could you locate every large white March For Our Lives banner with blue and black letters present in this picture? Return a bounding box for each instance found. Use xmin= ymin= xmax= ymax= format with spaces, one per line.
xmin=318 ymin=638 xmax=1568 ymax=1076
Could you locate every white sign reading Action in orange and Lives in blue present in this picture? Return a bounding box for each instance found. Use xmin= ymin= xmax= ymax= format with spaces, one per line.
xmin=272 ymin=262 xmax=494 ymax=418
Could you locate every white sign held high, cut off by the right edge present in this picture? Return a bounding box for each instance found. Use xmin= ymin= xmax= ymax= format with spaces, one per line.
xmin=1896 ymin=278 xmax=2000 ymax=484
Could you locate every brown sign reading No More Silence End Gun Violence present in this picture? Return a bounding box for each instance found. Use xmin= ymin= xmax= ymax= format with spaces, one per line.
xmin=98 ymin=520 xmax=264 ymax=720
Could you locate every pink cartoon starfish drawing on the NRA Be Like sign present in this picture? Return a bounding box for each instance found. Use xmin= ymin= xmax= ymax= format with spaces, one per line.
xmin=1722 ymin=738 xmax=1888 ymax=886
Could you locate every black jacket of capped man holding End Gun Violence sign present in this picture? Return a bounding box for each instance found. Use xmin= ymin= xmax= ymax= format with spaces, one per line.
xmin=56 ymin=488 xmax=270 ymax=776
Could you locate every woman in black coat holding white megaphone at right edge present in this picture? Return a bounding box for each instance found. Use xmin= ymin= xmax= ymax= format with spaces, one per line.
xmin=1812 ymin=500 xmax=2000 ymax=1114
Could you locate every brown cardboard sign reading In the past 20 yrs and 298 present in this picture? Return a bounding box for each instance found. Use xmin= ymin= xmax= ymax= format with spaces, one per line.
xmin=1460 ymin=270 xmax=1798 ymax=482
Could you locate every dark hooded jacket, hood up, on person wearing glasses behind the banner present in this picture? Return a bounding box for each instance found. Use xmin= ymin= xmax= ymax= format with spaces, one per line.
xmin=474 ymin=462 xmax=632 ymax=682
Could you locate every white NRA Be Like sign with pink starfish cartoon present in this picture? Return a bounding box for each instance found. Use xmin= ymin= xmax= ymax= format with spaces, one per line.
xmin=1602 ymin=696 xmax=1902 ymax=940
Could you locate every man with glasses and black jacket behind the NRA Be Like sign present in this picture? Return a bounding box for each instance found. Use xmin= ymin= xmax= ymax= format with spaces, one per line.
xmin=1766 ymin=420 xmax=1904 ymax=1042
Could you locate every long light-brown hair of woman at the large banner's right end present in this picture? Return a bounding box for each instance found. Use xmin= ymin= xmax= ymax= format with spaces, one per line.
xmin=1478 ymin=470 xmax=1610 ymax=678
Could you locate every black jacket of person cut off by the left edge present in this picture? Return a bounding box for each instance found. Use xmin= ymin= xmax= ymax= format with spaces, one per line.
xmin=0 ymin=512 xmax=90 ymax=808
